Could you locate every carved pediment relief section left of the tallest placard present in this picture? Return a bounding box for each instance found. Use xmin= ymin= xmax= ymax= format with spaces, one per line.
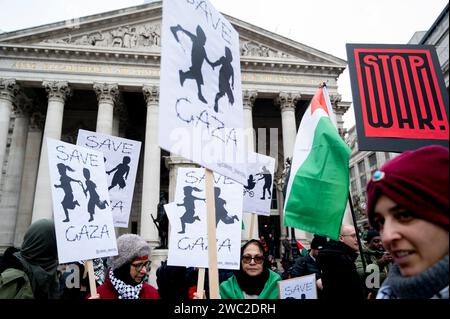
xmin=41 ymin=23 xmax=161 ymax=48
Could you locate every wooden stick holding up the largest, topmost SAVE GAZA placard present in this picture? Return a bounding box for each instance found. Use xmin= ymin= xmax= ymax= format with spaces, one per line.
xmin=205 ymin=169 xmax=220 ymax=299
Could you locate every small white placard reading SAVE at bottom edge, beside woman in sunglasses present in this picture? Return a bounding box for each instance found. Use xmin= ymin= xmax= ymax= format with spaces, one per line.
xmin=278 ymin=274 xmax=317 ymax=299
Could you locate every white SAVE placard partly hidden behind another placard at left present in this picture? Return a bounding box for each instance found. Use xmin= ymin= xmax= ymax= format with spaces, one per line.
xmin=77 ymin=130 xmax=141 ymax=227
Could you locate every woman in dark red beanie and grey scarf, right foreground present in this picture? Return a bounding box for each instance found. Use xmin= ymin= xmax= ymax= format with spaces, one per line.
xmin=367 ymin=146 xmax=449 ymax=299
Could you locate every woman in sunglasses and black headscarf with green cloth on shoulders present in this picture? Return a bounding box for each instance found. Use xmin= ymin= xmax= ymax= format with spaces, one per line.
xmin=219 ymin=239 xmax=281 ymax=299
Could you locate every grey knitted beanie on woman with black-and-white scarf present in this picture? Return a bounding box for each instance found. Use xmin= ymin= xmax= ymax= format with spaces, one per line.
xmin=109 ymin=234 xmax=150 ymax=270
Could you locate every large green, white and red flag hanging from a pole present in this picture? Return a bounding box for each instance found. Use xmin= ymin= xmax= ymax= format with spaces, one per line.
xmin=284 ymin=86 xmax=351 ymax=240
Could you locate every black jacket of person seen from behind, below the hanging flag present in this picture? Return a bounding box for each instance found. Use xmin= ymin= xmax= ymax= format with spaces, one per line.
xmin=317 ymin=240 xmax=364 ymax=300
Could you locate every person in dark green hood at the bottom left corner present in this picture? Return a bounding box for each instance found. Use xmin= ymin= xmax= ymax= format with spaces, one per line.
xmin=0 ymin=219 xmax=61 ymax=299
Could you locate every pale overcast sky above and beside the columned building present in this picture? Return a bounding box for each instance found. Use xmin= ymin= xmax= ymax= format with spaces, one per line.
xmin=0 ymin=0 xmax=448 ymax=127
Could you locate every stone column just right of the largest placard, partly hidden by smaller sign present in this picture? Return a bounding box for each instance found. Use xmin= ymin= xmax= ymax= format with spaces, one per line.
xmin=241 ymin=91 xmax=258 ymax=242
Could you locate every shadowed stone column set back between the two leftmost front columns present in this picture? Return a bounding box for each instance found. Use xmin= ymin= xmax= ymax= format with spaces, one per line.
xmin=14 ymin=112 xmax=45 ymax=247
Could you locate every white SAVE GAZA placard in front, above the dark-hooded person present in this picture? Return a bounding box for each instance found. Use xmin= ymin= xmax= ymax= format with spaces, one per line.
xmin=47 ymin=138 xmax=117 ymax=263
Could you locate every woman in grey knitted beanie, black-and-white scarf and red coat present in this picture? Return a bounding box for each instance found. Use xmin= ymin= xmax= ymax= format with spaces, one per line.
xmin=88 ymin=234 xmax=160 ymax=299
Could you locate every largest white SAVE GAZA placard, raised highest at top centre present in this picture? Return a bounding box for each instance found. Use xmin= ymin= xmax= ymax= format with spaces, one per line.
xmin=158 ymin=0 xmax=247 ymax=184
